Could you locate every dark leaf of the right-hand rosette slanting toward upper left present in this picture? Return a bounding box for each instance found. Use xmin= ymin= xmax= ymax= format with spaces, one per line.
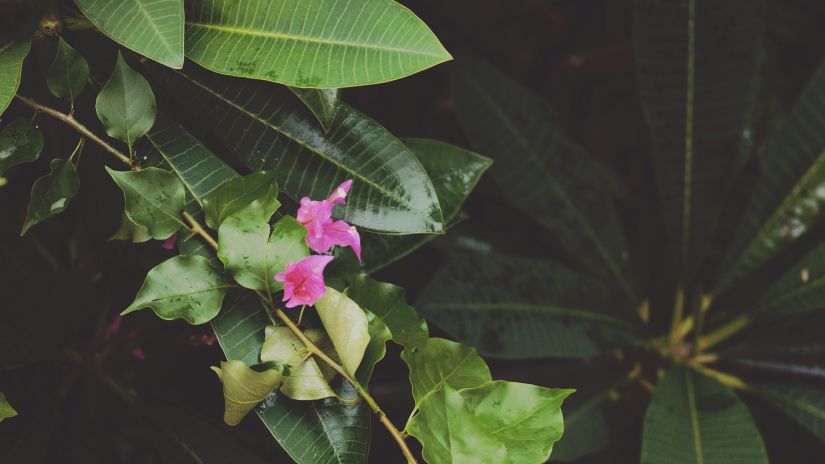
xmin=453 ymin=61 xmax=636 ymax=303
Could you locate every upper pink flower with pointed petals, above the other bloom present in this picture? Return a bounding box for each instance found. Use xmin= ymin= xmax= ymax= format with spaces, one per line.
xmin=296 ymin=179 xmax=361 ymax=261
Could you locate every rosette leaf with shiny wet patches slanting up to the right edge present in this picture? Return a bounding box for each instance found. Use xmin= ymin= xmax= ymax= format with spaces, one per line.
xmin=713 ymin=55 xmax=825 ymax=295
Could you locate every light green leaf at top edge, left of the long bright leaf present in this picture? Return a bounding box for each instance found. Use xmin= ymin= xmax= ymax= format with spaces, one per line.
xmin=75 ymin=0 xmax=183 ymax=69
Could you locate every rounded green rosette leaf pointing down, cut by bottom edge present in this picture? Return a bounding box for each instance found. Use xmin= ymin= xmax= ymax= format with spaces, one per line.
xmin=641 ymin=367 xmax=768 ymax=464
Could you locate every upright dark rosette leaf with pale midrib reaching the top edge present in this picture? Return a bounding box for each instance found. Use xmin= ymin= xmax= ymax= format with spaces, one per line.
xmin=634 ymin=0 xmax=763 ymax=278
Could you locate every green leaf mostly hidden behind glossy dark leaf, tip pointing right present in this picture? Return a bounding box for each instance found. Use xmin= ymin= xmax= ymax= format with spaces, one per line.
xmin=361 ymin=139 xmax=493 ymax=272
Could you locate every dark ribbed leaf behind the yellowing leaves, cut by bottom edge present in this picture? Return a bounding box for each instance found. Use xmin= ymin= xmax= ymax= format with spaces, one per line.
xmin=212 ymin=294 xmax=370 ymax=464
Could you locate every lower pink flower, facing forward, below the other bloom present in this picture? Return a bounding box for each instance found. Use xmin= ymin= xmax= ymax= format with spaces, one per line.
xmin=275 ymin=255 xmax=333 ymax=308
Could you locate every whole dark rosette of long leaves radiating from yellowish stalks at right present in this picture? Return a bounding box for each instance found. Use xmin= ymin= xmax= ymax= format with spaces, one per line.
xmin=419 ymin=0 xmax=825 ymax=463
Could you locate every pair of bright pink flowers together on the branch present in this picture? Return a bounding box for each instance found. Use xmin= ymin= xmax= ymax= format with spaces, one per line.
xmin=275 ymin=180 xmax=361 ymax=308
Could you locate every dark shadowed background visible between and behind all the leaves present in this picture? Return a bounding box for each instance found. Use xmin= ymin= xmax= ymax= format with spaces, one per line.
xmin=0 ymin=0 xmax=825 ymax=464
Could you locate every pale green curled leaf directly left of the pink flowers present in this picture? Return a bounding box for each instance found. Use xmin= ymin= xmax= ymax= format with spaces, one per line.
xmin=218 ymin=195 xmax=309 ymax=293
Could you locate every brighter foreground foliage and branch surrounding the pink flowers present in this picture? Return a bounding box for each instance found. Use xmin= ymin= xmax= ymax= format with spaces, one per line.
xmin=0 ymin=0 xmax=571 ymax=463
